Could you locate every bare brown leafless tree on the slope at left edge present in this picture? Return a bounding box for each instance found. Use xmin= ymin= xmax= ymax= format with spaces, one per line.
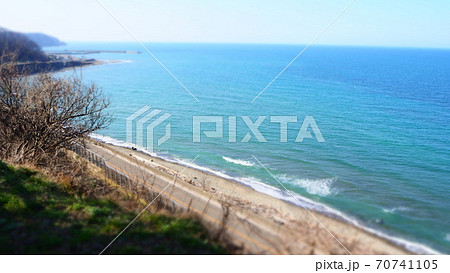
xmin=0 ymin=55 xmax=111 ymax=163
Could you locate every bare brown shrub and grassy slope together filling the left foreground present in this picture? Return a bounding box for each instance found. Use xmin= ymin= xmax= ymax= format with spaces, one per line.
xmin=0 ymin=54 xmax=224 ymax=254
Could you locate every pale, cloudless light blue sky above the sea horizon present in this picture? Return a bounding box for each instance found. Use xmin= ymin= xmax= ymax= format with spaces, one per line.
xmin=0 ymin=0 xmax=450 ymax=48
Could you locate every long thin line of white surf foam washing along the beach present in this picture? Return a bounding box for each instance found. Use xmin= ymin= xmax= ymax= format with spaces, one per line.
xmin=90 ymin=134 xmax=440 ymax=254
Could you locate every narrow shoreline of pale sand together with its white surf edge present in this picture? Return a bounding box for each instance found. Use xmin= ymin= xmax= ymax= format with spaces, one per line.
xmin=91 ymin=135 xmax=439 ymax=254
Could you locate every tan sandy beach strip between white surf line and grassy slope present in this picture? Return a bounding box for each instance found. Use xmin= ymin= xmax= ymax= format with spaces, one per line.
xmin=84 ymin=141 xmax=410 ymax=254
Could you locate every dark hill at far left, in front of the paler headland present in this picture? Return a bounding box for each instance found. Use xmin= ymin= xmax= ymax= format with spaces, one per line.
xmin=0 ymin=28 xmax=49 ymax=62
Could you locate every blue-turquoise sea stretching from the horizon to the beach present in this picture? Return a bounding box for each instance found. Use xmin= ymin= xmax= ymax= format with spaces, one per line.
xmin=48 ymin=43 xmax=450 ymax=254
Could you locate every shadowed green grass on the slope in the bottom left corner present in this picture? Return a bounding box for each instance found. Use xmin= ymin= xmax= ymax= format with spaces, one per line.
xmin=0 ymin=161 xmax=224 ymax=254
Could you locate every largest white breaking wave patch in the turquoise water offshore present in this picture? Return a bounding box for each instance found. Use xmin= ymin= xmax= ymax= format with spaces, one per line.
xmin=277 ymin=175 xmax=337 ymax=196
